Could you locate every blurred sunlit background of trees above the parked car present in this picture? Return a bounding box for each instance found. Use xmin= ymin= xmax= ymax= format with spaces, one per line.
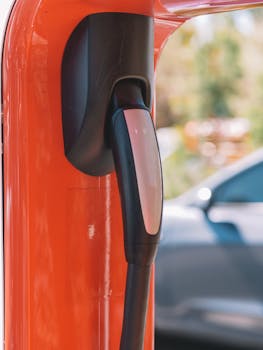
xmin=156 ymin=8 xmax=263 ymax=198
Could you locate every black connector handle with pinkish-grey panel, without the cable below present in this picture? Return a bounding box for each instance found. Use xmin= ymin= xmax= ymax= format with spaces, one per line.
xmin=112 ymin=108 xmax=163 ymax=265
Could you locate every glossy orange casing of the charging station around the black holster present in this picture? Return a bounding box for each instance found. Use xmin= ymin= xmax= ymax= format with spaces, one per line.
xmin=3 ymin=0 xmax=262 ymax=350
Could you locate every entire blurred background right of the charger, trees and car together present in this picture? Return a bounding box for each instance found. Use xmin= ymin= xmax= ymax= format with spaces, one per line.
xmin=155 ymin=8 xmax=263 ymax=350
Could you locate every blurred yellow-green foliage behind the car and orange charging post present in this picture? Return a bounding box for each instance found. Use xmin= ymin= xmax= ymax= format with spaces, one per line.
xmin=157 ymin=9 xmax=263 ymax=198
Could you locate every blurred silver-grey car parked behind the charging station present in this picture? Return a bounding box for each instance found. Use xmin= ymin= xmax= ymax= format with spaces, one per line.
xmin=156 ymin=149 xmax=263 ymax=350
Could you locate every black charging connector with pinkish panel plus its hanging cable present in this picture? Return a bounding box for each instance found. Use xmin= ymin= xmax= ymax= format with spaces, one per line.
xmin=110 ymin=79 xmax=162 ymax=350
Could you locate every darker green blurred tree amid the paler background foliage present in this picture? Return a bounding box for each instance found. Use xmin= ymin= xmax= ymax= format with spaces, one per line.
xmin=196 ymin=25 xmax=242 ymax=119
